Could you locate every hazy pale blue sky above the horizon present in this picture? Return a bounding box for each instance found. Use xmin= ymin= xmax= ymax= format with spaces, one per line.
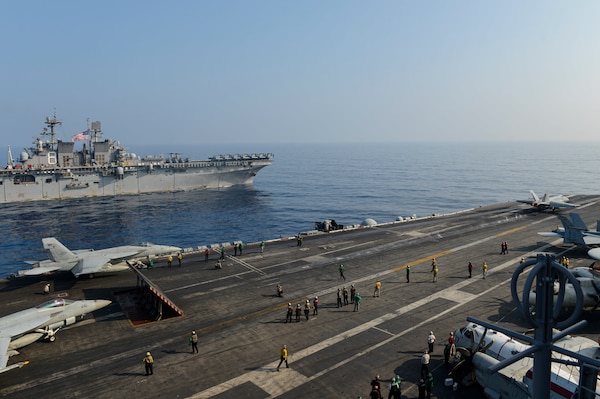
xmin=0 ymin=0 xmax=600 ymax=147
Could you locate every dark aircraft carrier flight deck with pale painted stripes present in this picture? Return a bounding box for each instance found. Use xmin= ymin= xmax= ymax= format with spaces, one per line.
xmin=0 ymin=195 xmax=600 ymax=399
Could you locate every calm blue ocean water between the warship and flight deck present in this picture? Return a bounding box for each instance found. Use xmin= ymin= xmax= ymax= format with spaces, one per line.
xmin=0 ymin=142 xmax=600 ymax=277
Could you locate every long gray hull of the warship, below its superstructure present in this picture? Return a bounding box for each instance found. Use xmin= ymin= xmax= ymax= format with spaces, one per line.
xmin=0 ymin=159 xmax=272 ymax=203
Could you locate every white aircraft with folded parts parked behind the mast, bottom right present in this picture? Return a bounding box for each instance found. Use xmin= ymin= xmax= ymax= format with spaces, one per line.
xmin=451 ymin=323 xmax=600 ymax=399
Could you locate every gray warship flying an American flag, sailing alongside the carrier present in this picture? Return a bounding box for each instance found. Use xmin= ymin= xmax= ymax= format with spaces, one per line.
xmin=0 ymin=114 xmax=273 ymax=203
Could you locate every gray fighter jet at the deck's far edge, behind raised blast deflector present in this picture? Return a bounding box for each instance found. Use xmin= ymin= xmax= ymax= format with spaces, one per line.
xmin=19 ymin=237 xmax=181 ymax=277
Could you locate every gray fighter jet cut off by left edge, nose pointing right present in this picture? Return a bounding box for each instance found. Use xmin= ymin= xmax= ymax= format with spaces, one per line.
xmin=0 ymin=298 xmax=111 ymax=373
